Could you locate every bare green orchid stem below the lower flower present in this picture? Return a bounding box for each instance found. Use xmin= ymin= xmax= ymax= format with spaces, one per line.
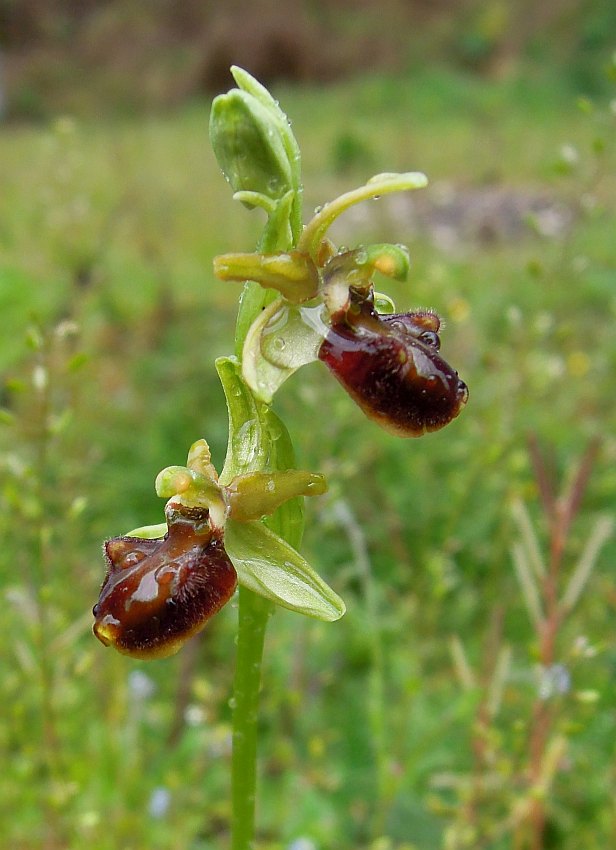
xmin=231 ymin=587 xmax=272 ymax=850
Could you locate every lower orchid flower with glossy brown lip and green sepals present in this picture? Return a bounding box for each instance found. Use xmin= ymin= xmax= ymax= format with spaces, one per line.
xmin=93 ymin=430 xmax=345 ymax=659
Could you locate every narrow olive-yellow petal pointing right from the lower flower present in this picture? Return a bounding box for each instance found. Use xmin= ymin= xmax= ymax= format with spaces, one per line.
xmin=224 ymin=469 xmax=327 ymax=522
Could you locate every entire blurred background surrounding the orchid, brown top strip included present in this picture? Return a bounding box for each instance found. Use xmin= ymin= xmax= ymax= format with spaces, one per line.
xmin=0 ymin=0 xmax=616 ymax=850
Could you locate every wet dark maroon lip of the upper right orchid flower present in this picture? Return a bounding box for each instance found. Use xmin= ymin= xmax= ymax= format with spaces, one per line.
xmin=319 ymin=298 xmax=468 ymax=437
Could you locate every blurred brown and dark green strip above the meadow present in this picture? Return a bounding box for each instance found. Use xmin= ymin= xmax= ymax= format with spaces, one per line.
xmin=0 ymin=0 xmax=616 ymax=119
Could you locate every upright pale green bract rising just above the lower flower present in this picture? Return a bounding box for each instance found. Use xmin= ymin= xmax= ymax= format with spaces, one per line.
xmin=215 ymin=357 xmax=270 ymax=486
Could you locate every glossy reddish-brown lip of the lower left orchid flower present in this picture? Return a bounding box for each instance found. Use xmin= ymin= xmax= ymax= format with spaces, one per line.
xmin=93 ymin=504 xmax=237 ymax=658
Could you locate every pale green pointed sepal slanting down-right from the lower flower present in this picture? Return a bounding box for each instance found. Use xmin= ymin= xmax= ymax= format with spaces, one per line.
xmin=225 ymin=520 xmax=346 ymax=622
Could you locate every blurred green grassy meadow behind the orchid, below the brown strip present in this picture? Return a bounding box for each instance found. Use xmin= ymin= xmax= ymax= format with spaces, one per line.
xmin=0 ymin=68 xmax=616 ymax=850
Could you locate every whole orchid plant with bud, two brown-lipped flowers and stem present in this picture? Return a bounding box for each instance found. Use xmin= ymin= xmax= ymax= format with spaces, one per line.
xmin=94 ymin=67 xmax=468 ymax=850
